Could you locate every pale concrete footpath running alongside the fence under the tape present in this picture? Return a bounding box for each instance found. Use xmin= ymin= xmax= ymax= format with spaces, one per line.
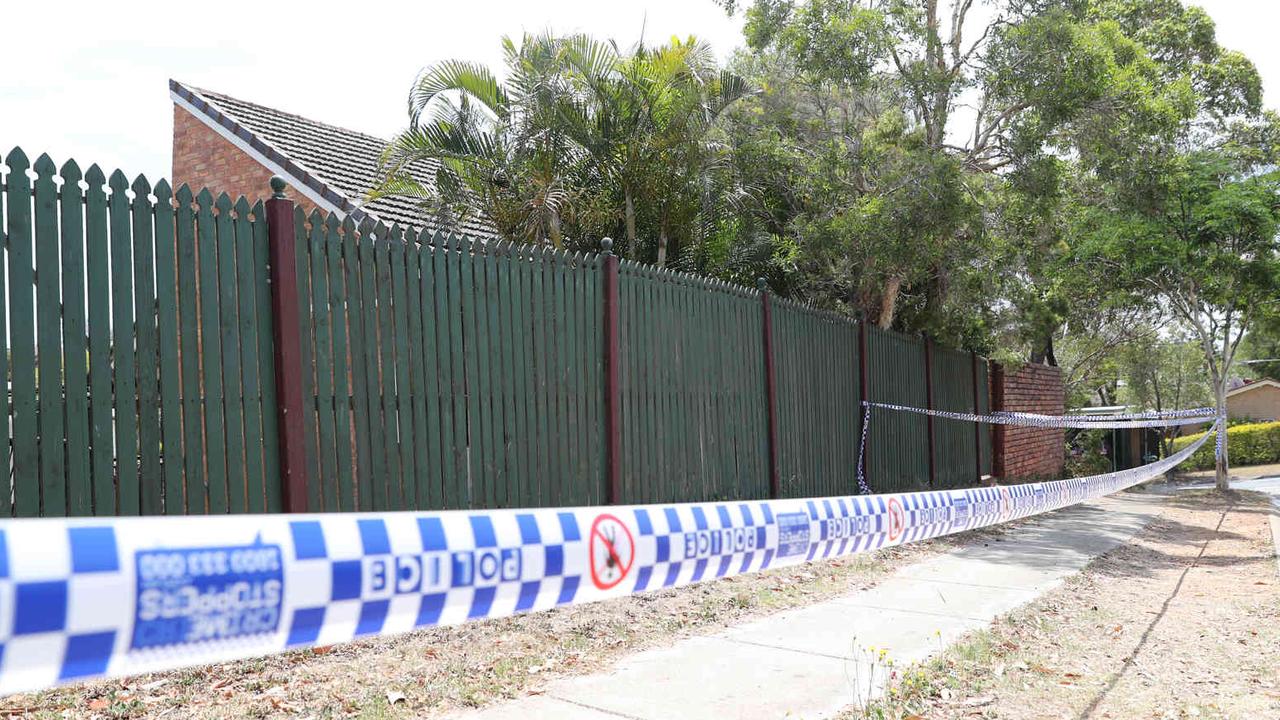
xmin=454 ymin=493 xmax=1162 ymax=720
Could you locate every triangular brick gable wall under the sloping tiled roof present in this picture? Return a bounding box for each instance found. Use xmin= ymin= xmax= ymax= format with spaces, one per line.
xmin=172 ymin=104 xmax=315 ymax=214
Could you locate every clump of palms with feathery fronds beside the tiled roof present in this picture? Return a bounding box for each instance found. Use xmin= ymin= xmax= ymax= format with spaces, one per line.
xmin=371 ymin=33 xmax=748 ymax=264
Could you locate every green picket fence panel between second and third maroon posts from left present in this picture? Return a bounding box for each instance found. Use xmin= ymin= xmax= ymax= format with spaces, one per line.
xmin=618 ymin=261 xmax=769 ymax=502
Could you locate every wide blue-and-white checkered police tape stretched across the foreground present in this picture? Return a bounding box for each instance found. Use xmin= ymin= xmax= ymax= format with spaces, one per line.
xmin=0 ymin=422 xmax=1208 ymax=693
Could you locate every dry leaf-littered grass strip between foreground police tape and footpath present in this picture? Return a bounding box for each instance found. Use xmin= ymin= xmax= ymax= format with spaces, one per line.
xmin=0 ymin=515 xmax=1009 ymax=720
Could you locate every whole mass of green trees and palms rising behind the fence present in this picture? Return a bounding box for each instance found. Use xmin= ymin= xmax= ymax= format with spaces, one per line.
xmin=375 ymin=0 xmax=1280 ymax=458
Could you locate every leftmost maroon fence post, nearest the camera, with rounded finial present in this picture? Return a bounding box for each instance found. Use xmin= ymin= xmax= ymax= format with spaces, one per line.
xmin=266 ymin=176 xmax=307 ymax=512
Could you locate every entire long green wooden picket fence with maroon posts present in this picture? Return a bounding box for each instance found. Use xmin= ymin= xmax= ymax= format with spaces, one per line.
xmin=0 ymin=150 xmax=991 ymax=518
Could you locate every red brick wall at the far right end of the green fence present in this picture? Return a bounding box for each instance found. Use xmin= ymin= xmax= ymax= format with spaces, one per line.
xmin=991 ymin=364 xmax=1066 ymax=479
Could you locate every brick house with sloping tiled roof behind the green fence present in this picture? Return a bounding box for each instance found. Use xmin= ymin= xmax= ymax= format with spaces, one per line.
xmin=169 ymin=79 xmax=497 ymax=240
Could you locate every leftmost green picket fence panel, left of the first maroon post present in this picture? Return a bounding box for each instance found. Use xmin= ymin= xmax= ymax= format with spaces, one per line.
xmin=0 ymin=150 xmax=279 ymax=516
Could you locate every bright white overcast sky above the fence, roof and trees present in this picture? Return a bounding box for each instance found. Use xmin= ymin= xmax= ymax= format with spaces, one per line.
xmin=0 ymin=0 xmax=1280 ymax=181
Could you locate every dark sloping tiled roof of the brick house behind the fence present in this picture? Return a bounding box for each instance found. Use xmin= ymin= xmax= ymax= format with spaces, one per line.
xmin=169 ymin=81 xmax=497 ymax=240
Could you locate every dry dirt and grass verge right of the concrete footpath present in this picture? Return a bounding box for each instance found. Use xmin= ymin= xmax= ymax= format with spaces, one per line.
xmin=846 ymin=491 xmax=1280 ymax=720
